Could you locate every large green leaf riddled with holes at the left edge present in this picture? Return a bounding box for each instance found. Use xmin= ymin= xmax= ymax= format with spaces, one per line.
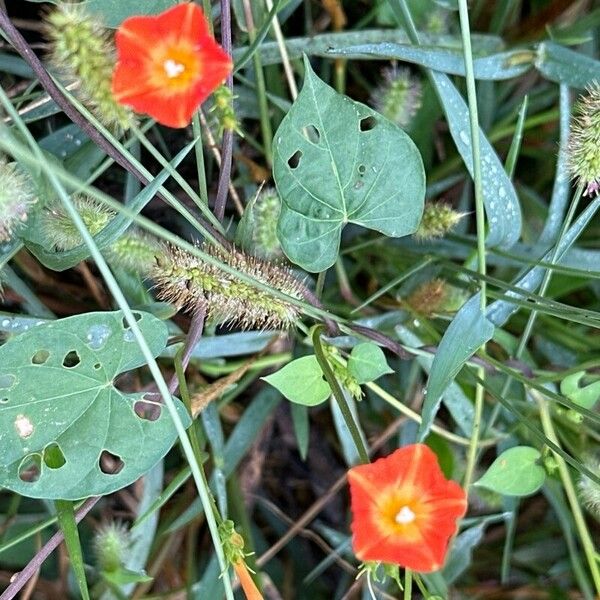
xmin=0 ymin=312 xmax=189 ymax=500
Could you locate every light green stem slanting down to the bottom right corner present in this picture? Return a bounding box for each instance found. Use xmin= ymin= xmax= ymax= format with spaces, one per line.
xmin=531 ymin=392 xmax=600 ymax=597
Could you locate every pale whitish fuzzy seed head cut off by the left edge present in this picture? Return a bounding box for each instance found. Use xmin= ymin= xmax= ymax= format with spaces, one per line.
xmin=0 ymin=157 xmax=37 ymax=243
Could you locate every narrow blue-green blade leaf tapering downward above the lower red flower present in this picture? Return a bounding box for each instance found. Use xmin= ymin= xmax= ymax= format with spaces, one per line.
xmin=418 ymin=294 xmax=494 ymax=440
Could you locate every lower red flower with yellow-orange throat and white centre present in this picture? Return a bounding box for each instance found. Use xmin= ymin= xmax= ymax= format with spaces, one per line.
xmin=348 ymin=444 xmax=467 ymax=573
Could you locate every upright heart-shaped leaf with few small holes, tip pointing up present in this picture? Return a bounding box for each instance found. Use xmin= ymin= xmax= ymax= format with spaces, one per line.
xmin=273 ymin=57 xmax=425 ymax=272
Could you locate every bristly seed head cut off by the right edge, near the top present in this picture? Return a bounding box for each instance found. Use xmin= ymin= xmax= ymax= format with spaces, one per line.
xmin=568 ymin=82 xmax=600 ymax=196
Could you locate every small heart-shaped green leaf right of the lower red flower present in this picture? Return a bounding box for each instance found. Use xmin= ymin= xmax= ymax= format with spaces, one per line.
xmin=473 ymin=446 xmax=546 ymax=496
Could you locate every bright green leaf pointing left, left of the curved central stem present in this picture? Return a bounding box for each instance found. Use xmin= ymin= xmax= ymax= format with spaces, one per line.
xmin=263 ymin=355 xmax=331 ymax=406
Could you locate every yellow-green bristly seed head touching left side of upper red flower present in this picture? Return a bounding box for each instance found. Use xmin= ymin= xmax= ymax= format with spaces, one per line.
xmin=46 ymin=2 xmax=133 ymax=131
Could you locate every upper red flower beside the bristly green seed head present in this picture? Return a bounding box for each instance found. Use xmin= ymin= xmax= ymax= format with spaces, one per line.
xmin=112 ymin=2 xmax=232 ymax=127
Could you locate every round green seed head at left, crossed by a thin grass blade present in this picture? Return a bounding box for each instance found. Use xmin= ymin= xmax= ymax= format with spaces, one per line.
xmin=42 ymin=195 xmax=115 ymax=251
